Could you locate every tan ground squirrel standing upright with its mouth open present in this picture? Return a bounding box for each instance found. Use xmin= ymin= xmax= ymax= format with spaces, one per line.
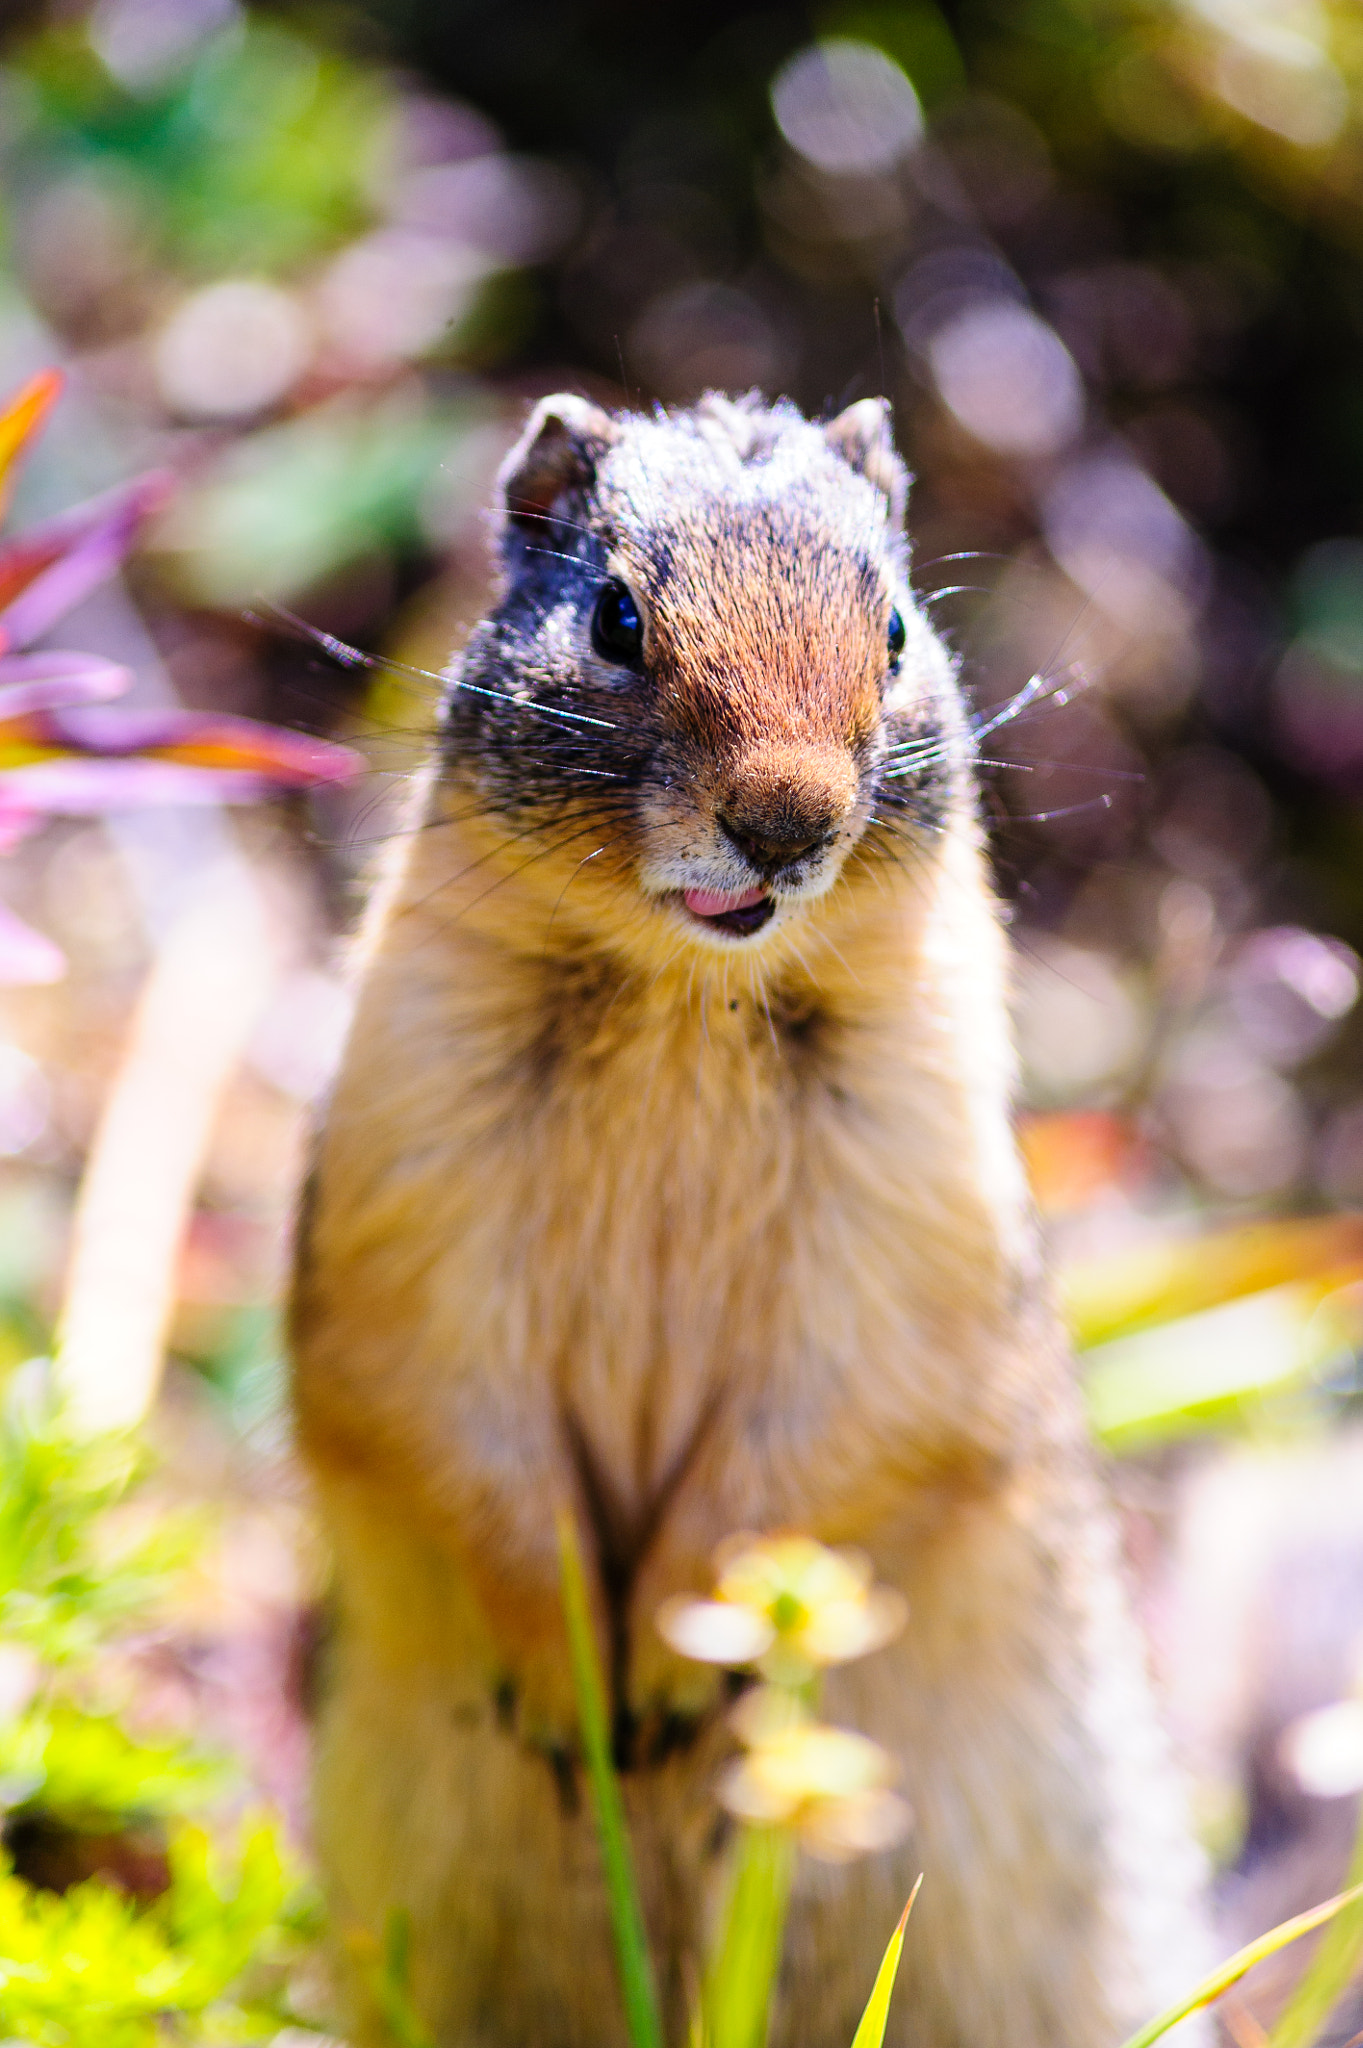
xmin=293 ymin=395 xmax=1201 ymax=2048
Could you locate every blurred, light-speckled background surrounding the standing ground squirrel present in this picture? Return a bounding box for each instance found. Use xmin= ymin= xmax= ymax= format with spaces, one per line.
xmin=0 ymin=0 xmax=1363 ymax=2042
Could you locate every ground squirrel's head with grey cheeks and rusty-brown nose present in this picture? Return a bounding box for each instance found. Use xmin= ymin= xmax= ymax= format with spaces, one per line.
xmin=442 ymin=395 xmax=968 ymax=950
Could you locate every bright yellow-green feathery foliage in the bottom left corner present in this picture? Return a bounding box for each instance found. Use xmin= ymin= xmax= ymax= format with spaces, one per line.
xmin=0 ymin=1368 xmax=327 ymax=2048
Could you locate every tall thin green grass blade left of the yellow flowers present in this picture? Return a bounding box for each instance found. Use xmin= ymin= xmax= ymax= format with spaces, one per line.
xmin=557 ymin=1509 xmax=663 ymax=2048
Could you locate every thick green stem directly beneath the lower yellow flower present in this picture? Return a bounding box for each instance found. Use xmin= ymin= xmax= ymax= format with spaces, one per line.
xmin=704 ymin=1827 xmax=796 ymax=2048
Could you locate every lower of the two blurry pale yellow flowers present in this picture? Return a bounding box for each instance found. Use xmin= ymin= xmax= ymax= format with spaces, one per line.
xmin=720 ymin=1688 xmax=913 ymax=1862
